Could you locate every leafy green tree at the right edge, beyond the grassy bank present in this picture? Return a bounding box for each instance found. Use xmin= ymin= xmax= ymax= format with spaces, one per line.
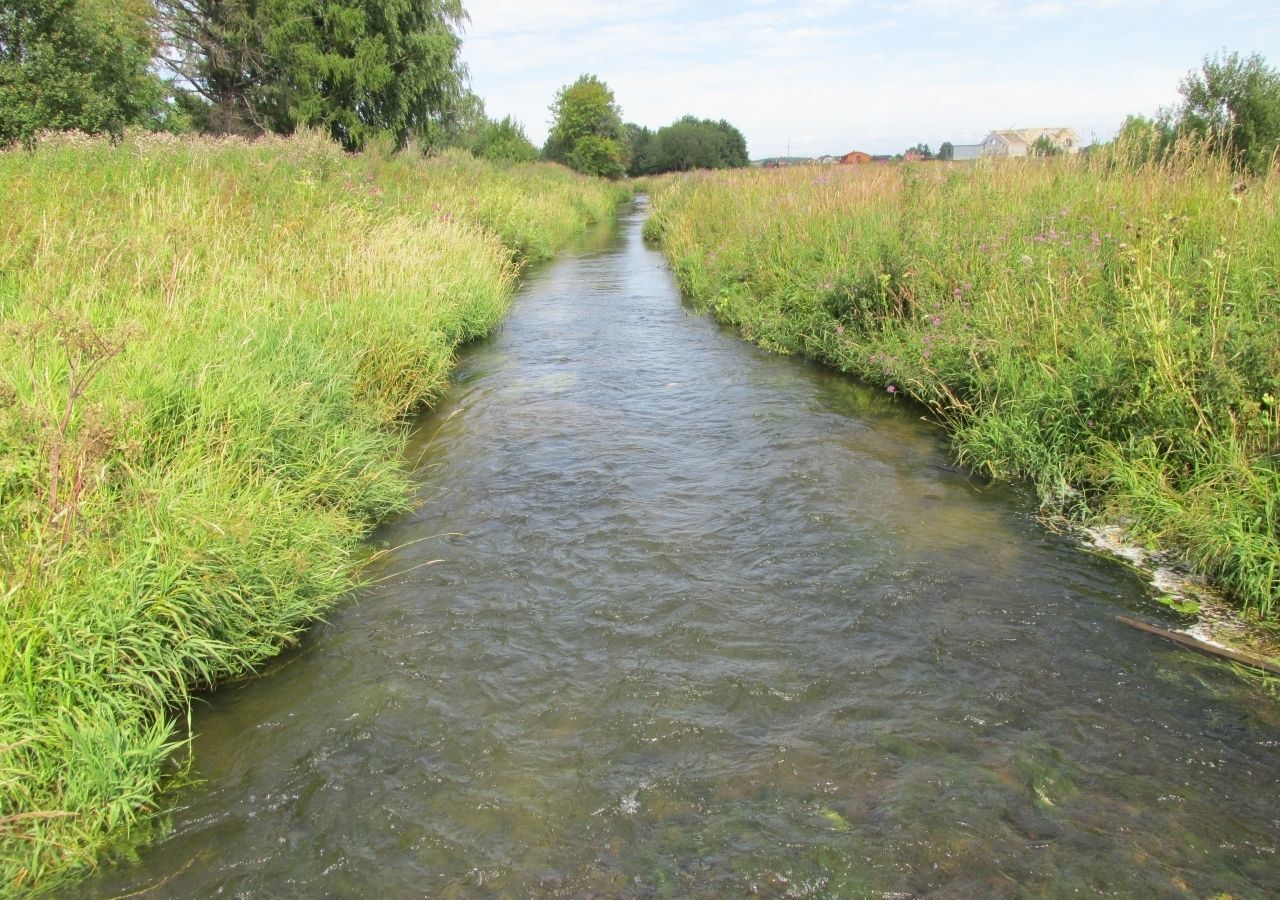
xmin=1178 ymin=52 xmax=1280 ymax=173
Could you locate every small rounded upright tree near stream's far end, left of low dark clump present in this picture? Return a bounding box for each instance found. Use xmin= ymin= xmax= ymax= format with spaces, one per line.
xmin=544 ymin=74 xmax=628 ymax=178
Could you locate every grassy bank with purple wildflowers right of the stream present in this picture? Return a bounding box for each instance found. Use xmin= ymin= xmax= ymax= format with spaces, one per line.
xmin=649 ymin=147 xmax=1280 ymax=627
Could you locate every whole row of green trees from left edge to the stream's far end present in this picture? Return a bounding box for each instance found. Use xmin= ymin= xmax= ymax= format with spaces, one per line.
xmin=0 ymin=6 xmax=748 ymax=178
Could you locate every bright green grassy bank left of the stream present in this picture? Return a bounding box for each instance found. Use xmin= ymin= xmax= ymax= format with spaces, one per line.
xmin=0 ymin=130 xmax=620 ymax=892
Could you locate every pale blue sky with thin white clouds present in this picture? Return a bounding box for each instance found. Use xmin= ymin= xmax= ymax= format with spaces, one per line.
xmin=462 ymin=0 xmax=1280 ymax=159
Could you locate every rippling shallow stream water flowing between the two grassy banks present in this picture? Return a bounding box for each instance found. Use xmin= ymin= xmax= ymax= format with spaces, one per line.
xmin=85 ymin=200 xmax=1280 ymax=899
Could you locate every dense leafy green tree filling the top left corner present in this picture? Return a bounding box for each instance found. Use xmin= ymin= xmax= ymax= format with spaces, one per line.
xmin=0 ymin=0 xmax=164 ymax=145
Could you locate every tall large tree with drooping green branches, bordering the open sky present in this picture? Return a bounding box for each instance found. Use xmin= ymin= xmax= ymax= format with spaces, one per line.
xmin=155 ymin=0 xmax=466 ymax=150
